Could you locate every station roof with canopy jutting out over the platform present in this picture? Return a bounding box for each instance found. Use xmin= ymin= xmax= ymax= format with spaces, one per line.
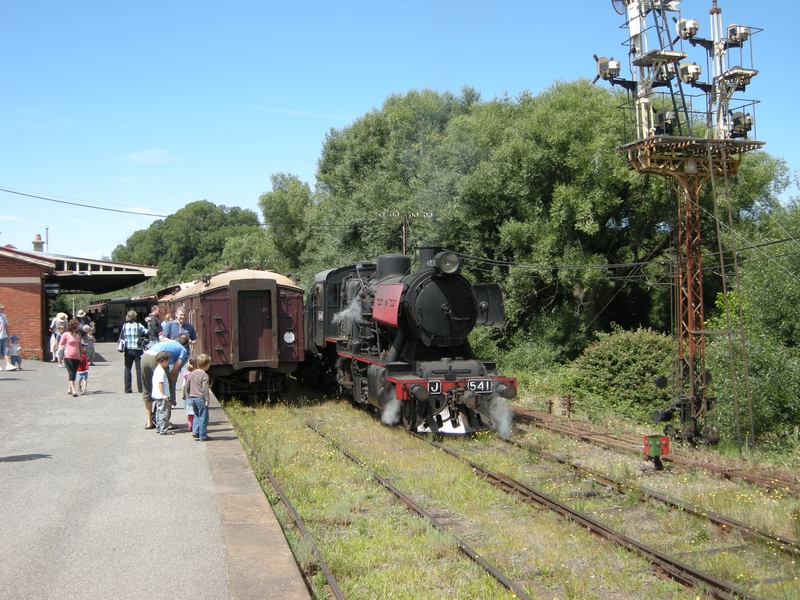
xmin=0 ymin=246 xmax=158 ymax=294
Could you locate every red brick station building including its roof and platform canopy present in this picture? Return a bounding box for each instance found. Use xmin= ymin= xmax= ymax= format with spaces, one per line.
xmin=0 ymin=240 xmax=158 ymax=360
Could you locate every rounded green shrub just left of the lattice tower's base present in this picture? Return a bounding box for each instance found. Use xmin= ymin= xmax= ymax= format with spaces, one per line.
xmin=566 ymin=329 xmax=675 ymax=422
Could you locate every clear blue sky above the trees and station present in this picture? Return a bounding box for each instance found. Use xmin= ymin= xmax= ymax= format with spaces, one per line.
xmin=0 ymin=0 xmax=800 ymax=258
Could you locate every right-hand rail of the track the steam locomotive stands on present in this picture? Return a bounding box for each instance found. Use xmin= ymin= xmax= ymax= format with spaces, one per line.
xmin=501 ymin=438 xmax=800 ymax=556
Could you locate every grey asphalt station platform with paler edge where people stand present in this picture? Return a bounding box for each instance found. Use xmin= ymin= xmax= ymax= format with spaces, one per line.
xmin=0 ymin=343 xmax=309 ymax=600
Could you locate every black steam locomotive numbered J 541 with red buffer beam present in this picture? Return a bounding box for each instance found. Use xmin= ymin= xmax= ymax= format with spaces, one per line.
xmin=305 ymin=247 xmax=517 ymax=433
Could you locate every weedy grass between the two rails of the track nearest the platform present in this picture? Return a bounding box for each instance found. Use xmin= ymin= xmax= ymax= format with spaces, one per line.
xmin=226 ymin=403 xmax=514 ymax=599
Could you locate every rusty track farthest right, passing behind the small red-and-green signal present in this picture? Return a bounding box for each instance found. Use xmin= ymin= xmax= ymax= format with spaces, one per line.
xmin=514 ymin=407 xmax=800 ymax=494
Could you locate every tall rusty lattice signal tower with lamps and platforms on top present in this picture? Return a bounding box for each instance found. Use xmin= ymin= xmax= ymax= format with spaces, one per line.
xmin=595 ymin=0 xmax=764 ymax=443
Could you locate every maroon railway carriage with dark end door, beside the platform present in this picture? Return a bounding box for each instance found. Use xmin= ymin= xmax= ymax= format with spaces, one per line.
xmin=167 ymin=269 xmax=304 ymax=397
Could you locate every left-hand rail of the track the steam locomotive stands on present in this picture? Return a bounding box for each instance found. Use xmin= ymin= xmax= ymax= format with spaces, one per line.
xmin=422 ymin=434 xmax=758 ymax=600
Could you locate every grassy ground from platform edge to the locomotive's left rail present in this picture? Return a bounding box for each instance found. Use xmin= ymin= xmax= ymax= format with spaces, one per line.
xmin=226 ymin=400 xmax=705 ymax=600
